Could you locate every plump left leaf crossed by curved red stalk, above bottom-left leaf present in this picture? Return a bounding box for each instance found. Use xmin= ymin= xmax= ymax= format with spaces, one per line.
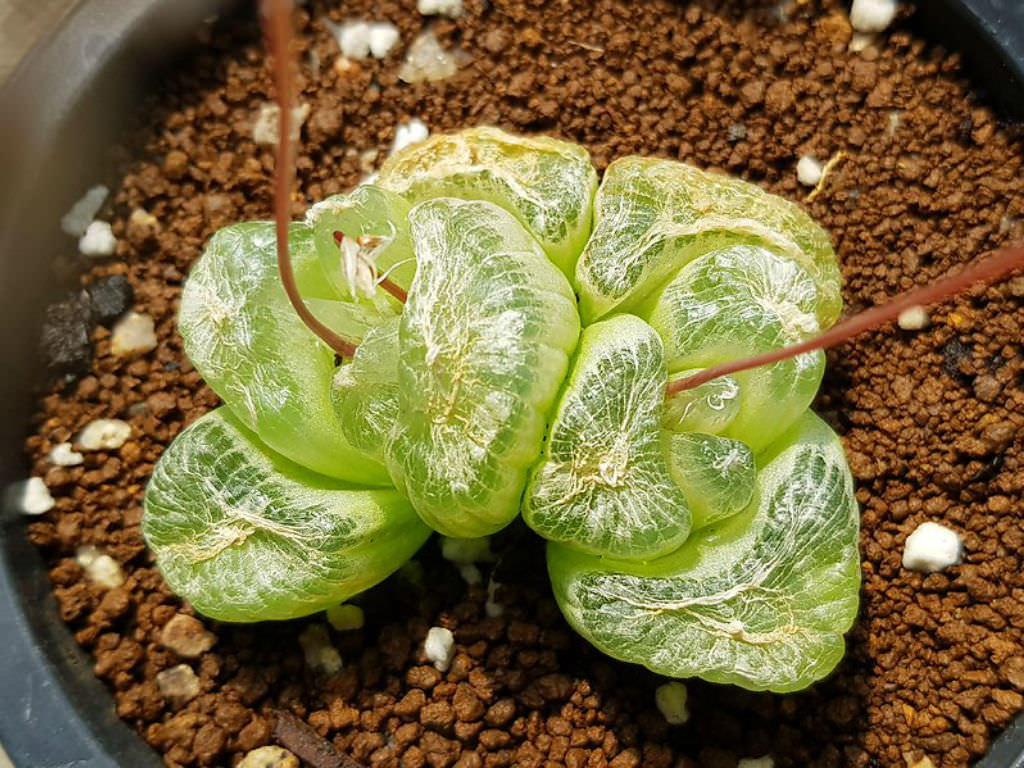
xmin=178 ymin=222 xmax=388 ymax=484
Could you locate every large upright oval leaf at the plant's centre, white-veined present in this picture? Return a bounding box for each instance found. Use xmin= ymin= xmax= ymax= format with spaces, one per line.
xmin=387 ymin=199 xmax=580 ymax=537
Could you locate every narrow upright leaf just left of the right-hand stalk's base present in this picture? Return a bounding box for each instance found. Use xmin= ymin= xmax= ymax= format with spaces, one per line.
xmin=522 ymin=314 xmax=690 ymax=558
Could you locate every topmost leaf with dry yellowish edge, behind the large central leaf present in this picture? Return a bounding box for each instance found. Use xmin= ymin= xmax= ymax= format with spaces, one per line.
xmin=376 ymin=127 xmax=597 ymax=275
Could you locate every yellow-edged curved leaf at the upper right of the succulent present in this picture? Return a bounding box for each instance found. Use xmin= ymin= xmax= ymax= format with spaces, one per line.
xmin=575 ymin=157 xmax=842 ymax=328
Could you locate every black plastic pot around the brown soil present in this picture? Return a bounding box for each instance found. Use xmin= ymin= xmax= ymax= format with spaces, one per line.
xmin=0 ymin=0 xmax=1024 ymax=768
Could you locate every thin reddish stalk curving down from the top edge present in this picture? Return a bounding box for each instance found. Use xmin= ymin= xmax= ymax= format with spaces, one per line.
xmin=263 ymin=0 xmax=356 ymax=357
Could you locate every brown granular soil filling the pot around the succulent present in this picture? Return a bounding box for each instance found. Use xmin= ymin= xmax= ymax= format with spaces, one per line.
xmin=19 ymin=0 xmax=1024 ymax=768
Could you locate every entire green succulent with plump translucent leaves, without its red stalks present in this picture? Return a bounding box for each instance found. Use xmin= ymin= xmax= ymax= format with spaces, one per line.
xmin=143 ymin=128 xmax=859 ymax=690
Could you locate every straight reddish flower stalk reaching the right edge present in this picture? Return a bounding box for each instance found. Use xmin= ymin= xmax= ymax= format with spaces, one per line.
xmin=666 ymin=246 xmax=1024 ymax=397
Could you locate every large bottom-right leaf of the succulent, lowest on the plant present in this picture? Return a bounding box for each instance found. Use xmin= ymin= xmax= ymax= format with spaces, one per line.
xmin=548 ymin=413 xmax=860 ymax=691
